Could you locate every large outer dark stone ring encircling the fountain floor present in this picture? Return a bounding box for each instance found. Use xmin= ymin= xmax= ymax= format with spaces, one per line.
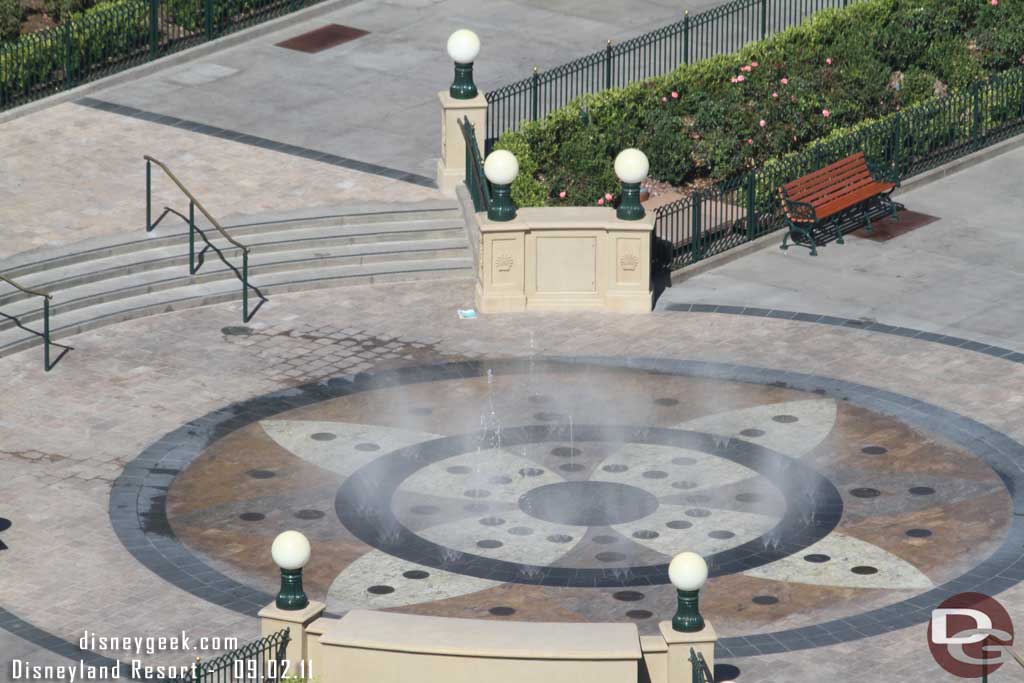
xmin=105 ymin=356 xmax=1024 ymax=664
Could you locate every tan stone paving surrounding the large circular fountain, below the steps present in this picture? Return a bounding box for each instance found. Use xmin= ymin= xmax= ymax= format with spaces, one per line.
xmin=0 ymin=270 xmax=1024 ymax=681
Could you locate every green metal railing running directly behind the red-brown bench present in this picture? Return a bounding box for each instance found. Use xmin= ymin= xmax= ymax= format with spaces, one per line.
xmin=652 ymin=68 xmax=1024 ymax=270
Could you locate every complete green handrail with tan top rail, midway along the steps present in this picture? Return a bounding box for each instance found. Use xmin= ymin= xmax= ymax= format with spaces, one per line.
xmin=143 ymin=155 xmax=267 ymax=323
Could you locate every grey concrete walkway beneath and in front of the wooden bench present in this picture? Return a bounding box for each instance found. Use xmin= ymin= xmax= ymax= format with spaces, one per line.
xmin=658 ymin=143 xmax=1024 ymax=349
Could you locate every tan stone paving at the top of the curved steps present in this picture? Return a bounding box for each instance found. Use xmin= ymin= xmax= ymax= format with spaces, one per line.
xmin=0 ymin=103 xmax=440 ymax=258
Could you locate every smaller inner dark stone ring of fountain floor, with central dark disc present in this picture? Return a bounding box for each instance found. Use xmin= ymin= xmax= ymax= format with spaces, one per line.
xmin=335 ymin=425 xmax=843 ymax=588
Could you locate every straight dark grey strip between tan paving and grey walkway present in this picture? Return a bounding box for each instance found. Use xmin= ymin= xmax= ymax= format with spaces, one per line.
xmin=75 ymin=97 xmax=437 ymax=189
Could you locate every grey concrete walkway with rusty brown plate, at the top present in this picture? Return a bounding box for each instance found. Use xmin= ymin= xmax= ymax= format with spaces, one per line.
xmin=83 ymin=0 xmax=718 ymax=178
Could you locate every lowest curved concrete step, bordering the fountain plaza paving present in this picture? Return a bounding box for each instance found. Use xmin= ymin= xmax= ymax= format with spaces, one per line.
xmin=0 ymin=257 xmax=473 ymax=357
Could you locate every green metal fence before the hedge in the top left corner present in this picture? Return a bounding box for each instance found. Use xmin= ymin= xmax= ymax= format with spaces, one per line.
xmin=0 ymin=0 xmax=319 ymax=111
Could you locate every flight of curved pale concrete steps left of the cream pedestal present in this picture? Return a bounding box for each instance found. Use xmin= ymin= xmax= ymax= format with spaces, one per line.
xmin=0 ymin=201 xmax=474 ymax=356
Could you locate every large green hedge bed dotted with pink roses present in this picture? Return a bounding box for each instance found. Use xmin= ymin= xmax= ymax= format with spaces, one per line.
xmin=496 ymin=0 xmax=1024 ymax=206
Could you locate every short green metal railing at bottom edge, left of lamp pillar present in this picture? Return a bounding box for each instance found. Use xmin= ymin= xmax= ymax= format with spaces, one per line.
xmin=163 ymin=629 xmax=292 ymax=683
